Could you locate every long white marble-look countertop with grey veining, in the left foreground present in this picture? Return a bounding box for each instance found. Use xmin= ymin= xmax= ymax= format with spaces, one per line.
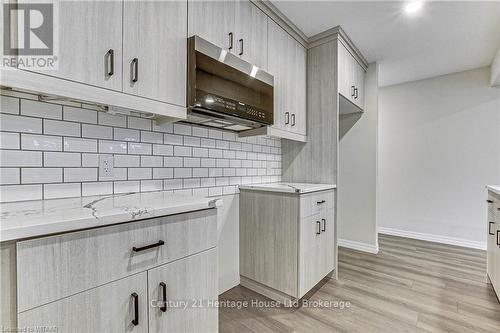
xmin=0 ymin=191 xmax=222 ymax=242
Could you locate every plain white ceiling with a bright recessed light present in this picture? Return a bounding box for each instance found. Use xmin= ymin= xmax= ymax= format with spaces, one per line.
xmin=272 ymin=0 xmax=500 ymax=86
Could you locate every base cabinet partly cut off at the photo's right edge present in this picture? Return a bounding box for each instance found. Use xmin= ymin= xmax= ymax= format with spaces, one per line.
xmin=487 ymin=191 xmax=500 ymax=300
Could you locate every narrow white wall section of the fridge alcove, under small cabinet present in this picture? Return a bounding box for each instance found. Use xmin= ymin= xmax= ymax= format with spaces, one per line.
xmin=337 ymin=63 xmax=378 ymax=253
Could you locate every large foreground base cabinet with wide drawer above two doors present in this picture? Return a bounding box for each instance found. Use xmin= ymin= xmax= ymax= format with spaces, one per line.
xmin=11 ymin=208 xmax=218 ymax=333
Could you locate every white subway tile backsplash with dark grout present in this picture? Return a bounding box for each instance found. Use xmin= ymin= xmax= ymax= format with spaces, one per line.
xmin=0 ymin=94 xmax=281 ymax=200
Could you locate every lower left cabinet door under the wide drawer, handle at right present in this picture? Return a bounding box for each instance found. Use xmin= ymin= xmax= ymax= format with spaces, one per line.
xmin=18 ymin=272 xmax=148 ymax=333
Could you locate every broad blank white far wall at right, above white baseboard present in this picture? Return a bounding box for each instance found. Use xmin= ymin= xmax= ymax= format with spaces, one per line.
xmin=378 ymin=68 xmax=500 ymax=248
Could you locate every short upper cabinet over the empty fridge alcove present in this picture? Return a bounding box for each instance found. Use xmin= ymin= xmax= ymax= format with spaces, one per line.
xmin=338 ymin=40 xmax=365 ymax=110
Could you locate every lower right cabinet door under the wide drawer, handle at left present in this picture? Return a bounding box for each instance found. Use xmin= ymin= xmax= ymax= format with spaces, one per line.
xmin=148 ymin=249 xmax=218 ymax=333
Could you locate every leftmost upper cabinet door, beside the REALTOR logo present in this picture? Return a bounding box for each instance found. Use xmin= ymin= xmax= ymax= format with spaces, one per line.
xmin=23 ymin=0 xmax=122 ymax=91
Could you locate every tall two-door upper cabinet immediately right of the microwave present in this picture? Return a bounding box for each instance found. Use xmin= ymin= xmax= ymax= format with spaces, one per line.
xmin=268 ymin=20 xmax=307 ymax=141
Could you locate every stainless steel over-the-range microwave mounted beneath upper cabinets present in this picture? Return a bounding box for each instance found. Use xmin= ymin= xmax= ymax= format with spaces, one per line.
xmin=186 ymin=36 xmax=274 ymax=132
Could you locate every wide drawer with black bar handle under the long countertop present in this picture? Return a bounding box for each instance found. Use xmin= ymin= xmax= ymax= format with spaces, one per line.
xmin=17 ymin=209 xmax=217 ymax=312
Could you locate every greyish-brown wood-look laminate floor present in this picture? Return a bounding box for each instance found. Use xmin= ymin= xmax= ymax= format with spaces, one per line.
xmin=219 ymin=235 xmax=500 ymax=333
